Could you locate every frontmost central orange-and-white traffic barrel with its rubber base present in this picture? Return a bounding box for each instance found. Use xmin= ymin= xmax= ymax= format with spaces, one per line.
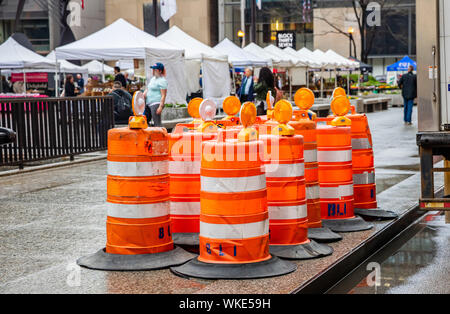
xmin=171 ymin=103 xmax=296 ymax=279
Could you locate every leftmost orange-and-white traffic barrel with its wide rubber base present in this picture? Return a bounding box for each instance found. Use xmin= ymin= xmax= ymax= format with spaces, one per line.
xmin=78 ymin=94 xmax=193 ymax=270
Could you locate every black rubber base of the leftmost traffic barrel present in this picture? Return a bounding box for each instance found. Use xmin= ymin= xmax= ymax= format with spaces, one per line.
xmin=77 ymin=247 xmax=195 ymax=271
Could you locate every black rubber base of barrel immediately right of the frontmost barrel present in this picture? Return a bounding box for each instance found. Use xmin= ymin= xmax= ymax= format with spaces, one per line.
xmin=270 ymin=240 xmax=333 ymax=260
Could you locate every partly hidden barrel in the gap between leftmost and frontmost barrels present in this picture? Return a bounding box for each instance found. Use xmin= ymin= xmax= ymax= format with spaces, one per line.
xmin=168 ymin=132 xmax=217 ymax=245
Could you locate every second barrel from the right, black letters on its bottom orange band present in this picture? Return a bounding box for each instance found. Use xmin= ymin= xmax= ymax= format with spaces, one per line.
xmin=317 ymin=102 xmax=373 ymax=232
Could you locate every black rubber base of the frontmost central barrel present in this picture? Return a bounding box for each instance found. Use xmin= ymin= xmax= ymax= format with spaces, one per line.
xmin=170 ymin=256 xmax=297 ymax=279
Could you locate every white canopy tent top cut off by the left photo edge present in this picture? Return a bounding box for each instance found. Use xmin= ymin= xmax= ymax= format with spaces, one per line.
xmin=0 ymin=37 xmax=55 ymax=69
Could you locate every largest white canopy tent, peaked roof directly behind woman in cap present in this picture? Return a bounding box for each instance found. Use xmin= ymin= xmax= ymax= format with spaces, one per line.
xmin=56 ymin=19 xmax=187 ymax=103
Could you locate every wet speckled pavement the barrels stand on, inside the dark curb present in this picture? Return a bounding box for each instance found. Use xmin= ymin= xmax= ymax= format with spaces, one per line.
xmin=0 ymin=108 xmax=442 ymax=294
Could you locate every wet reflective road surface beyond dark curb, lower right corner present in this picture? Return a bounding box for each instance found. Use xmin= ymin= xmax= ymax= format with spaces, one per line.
xmin=329 ymin=213 xmax=450 ymax=294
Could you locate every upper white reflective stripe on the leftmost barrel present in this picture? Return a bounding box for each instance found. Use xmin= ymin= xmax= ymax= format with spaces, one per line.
xmin=107 ymin=160 xmax=169 ymax=177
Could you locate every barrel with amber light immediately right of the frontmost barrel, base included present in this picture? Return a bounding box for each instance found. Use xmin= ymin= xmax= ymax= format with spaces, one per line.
xmin=261 ymin=100 xmax=333 ymax=259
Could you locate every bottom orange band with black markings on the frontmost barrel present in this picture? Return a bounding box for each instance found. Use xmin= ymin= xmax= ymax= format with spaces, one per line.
xmin=198 ymin=234 xmax=271 ymax=264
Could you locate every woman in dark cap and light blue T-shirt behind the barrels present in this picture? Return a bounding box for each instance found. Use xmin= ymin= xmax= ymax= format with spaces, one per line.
xmin=144 ymin=62 xmax=167 ymax=127
